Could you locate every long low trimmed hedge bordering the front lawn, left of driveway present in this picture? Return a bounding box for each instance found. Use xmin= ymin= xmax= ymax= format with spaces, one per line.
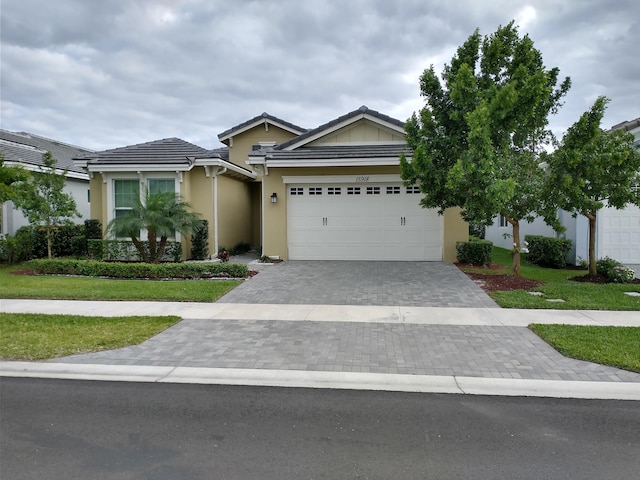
xmin=27 ymin=259 xmax=249 ymax=279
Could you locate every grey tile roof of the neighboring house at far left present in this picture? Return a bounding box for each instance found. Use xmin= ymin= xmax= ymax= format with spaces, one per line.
xmin=0 ymin=130 xmax=93 ymax=174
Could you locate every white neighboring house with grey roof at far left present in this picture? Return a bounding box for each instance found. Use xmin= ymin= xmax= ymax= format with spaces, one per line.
xmin=0 ymin=130 xmax=91 ymax=235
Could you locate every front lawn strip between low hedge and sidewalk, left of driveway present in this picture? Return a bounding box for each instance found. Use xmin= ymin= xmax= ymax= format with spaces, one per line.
xmin=0 ymin=265 xmax=242 ymax=302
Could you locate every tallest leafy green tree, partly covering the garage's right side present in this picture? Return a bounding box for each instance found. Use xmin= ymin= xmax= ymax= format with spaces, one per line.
xmin=401 ymin=22 xmax=571 ymax=275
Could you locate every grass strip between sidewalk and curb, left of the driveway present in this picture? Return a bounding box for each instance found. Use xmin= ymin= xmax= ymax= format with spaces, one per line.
xmin=0 ymin=313 xmax=180 ymax=361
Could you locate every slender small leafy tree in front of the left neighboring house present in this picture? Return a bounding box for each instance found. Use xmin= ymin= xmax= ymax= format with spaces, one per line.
xmin=14 ymin=152 xmax=82 ymax=258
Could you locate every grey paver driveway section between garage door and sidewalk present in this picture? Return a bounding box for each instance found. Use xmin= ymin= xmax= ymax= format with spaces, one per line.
xmin=218 ymin=260 xmax=497 ymax=308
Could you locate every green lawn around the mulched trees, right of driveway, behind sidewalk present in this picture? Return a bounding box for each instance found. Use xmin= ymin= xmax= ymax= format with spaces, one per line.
xmin=464 ymin=247 xmax=640 ymax=310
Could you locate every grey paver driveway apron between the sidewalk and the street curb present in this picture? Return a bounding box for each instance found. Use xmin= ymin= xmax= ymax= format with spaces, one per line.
xmin=53 ymin=320 xmax=640 ymax=382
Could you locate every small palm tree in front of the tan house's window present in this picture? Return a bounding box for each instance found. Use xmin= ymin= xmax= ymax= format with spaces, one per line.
xmin=107 ymin=191 xmax=200 ymax=263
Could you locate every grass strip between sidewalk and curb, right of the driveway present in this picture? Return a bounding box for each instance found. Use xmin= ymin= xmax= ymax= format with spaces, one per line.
xmin=529 ymin=323 xmax=640 ymax=373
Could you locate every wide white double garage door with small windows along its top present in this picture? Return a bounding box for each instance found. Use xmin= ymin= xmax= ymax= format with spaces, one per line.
xmin=287 ymin=183 xmax=443 ymax=261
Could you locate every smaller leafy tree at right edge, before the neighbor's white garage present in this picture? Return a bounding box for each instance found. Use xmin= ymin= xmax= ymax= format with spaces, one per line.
xmin=546 ymin=97 xmax=640 ymax=275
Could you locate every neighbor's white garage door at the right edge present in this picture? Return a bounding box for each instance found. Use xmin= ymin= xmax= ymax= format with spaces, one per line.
xmin=598 ymin=205 xmax=640 ymax=264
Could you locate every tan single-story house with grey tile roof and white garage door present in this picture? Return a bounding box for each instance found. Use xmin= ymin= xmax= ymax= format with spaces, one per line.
xmin=75 ymin=106 xmax=468 ymax=262
